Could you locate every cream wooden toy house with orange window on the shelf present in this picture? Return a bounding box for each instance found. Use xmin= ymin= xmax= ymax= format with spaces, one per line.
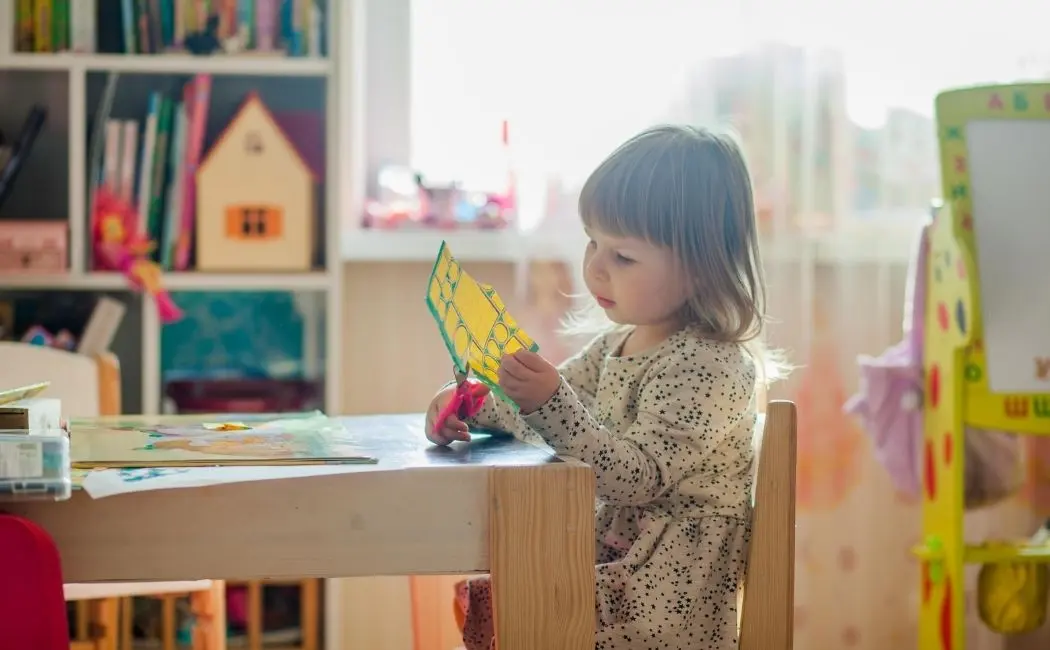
xmin=195 ymin=92 xmax=317 ymax=273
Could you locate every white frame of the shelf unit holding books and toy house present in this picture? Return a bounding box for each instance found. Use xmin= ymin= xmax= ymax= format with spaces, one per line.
xmin=0 ymin=5 xmax=354 ymax=414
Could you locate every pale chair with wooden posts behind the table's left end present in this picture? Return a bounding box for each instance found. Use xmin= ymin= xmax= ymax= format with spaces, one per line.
xmin=0 ymin=341 xmax=226 ymax=650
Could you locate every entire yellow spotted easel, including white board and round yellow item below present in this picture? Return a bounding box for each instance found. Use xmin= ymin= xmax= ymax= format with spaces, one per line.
xmin=917 ymin=84 xmax=1050 ymax=650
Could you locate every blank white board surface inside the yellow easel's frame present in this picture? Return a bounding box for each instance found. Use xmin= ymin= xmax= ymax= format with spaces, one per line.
xmin=966 ymin=120 xmax=1050 ymax=394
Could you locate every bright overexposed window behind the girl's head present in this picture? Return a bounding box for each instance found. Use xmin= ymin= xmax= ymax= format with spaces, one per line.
xmin=382 ymin=0 xmax=1050 ymax=237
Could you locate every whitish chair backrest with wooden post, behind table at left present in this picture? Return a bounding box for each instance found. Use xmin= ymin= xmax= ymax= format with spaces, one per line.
xmin=0 ymin=341 xmax=121 ymax=418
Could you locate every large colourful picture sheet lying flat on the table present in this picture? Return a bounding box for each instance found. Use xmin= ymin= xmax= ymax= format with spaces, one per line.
xmin=70 ymin=414 xmax=375 ymax=468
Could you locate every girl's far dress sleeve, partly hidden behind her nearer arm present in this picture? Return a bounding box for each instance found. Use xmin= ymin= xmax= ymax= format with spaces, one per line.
xmin=467 ymin=336 xmax=607 ymax=442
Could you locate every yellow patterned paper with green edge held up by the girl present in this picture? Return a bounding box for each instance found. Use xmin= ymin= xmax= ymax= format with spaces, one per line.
xmin=426 ymin=242 xmax=540 ymax=398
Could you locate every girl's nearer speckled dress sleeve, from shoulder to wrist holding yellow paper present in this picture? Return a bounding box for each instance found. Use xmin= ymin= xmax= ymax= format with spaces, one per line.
xmin=522 ymin=345 xmax=755 ymax=505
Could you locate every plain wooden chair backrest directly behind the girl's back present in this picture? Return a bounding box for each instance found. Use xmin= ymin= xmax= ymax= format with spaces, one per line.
xmin=739 ymin=401 xmax=798 ymax=650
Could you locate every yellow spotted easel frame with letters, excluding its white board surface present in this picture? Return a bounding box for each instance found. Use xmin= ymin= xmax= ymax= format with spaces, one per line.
xmin=916 ymin=84 xmax=1050 ymax=650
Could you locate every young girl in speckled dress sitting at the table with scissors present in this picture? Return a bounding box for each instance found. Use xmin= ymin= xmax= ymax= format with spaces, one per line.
xmin=426 ymin=126 xmax=781 ymax=650
